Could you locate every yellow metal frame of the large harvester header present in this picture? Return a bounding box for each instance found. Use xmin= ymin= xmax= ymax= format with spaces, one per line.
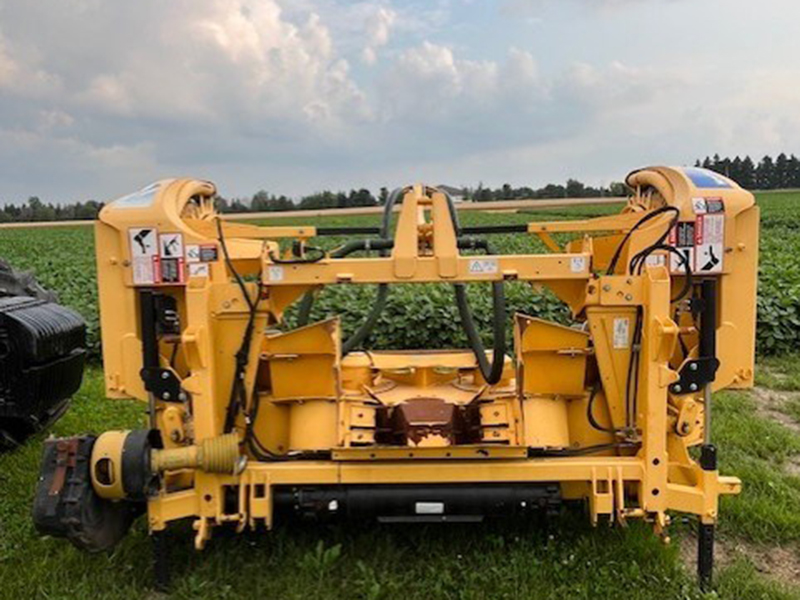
xmin=96 ymin=167 xmax=758 ymax=548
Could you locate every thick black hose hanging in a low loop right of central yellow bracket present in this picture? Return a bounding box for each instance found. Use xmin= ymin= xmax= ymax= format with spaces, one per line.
xmin=444 ymin=186 xmax=506 ymax=385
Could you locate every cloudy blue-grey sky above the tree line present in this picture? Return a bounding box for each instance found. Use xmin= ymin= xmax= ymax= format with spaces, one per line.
xmin=0 ymin=0 xmax=800 ymax=203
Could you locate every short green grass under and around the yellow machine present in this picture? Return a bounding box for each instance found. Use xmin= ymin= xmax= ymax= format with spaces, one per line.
xmin=0 ymin=368 xmax=800 ymax=600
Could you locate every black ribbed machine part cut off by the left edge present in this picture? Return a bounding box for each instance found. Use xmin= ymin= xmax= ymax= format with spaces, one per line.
xmin=0 ymin=290 xmax=86 ymax=447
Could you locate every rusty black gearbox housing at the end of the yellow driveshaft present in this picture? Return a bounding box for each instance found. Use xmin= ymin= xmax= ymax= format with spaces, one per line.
xmin=33 ymin=436 xmax=144 ymax=552
